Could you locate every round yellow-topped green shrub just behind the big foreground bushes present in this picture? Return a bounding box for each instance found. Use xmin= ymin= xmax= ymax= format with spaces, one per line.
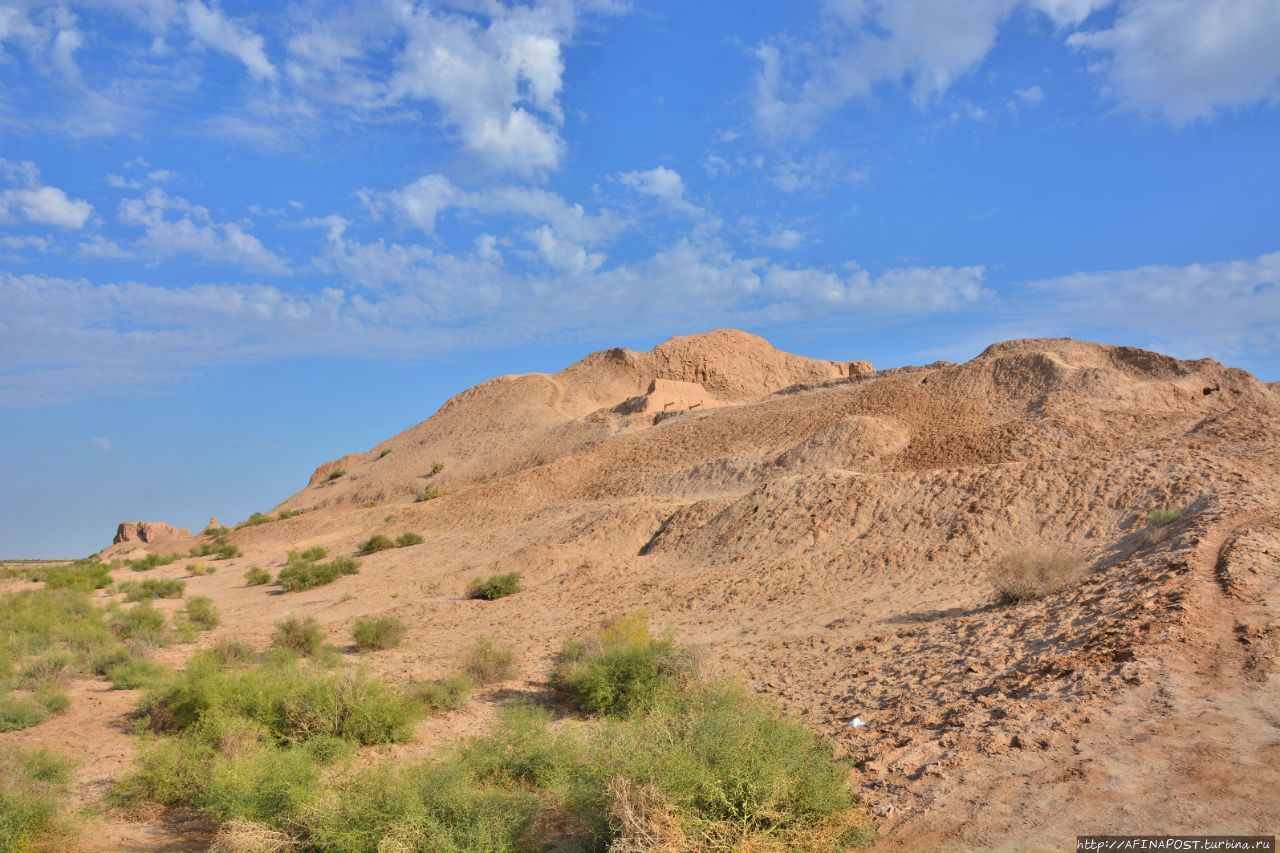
xmin=552 ymin=612 xmax=696 ymax=716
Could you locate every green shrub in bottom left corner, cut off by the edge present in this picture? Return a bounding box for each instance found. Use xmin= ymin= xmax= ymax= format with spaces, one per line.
xmin=0 ymin=745 xmax=74 ymax=853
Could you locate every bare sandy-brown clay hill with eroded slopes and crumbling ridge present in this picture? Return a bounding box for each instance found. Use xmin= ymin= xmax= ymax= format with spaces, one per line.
xmin=18 ymin=330 xmax=1280 ymax=849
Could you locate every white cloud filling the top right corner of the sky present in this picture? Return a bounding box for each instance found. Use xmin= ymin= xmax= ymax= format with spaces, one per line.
xmin=1068 ymin=0 xmax=1280 ymax=124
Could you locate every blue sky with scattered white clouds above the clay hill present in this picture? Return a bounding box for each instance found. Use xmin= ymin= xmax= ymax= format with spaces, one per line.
xmin=0 ymin=0 xmax=1280 ymax=556
